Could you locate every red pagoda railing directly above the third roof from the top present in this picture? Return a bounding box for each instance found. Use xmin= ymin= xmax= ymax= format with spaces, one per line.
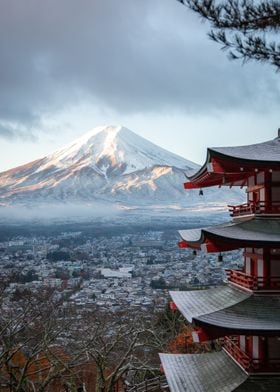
xmin=225 ymin=269 xmax=280 ymax=290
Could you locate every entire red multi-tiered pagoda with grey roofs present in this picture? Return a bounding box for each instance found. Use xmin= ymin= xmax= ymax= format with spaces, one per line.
xmin=160 ymin=130 xmax=280 ymax=392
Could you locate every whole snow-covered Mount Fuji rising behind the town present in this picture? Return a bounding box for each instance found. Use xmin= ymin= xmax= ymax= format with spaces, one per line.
xmin=0 ymin=126 xmax=243 ymax=216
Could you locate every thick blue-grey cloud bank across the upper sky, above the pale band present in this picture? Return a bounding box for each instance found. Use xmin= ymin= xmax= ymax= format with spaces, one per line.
xmin=0 ymin=0 xmax=279 ymax=138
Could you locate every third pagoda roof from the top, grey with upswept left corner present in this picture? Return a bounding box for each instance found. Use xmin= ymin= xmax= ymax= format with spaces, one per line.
xmin=170 ymin=285 xmax=280 ymax=334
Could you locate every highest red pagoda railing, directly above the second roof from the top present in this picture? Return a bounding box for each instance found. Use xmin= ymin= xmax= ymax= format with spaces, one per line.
xmin=228 ymin=201 xmax=280 ymax=217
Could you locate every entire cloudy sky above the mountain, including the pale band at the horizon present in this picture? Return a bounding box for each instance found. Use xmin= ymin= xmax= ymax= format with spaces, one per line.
xmin=0 ymin=0 xmax=280 ymax=170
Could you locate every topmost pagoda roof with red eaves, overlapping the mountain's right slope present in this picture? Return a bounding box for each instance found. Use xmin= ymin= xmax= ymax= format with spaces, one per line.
xmin=185 ymin=136 xmax=280 ymax=189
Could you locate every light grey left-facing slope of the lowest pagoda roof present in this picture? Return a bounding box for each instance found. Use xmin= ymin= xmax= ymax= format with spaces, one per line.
xmin=160 ymin=351 xmax=248 ymax=392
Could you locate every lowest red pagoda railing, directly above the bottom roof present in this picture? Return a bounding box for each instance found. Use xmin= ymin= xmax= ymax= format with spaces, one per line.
xmin=223 ymin=336 xmax=280 ymax=373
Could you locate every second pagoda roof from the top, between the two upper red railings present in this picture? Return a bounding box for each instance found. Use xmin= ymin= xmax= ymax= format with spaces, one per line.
xmin=179 ymin=217 xmax=280 ymax=252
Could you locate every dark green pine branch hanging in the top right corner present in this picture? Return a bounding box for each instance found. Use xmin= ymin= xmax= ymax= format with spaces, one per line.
xmin=177 ymin=0 xmax=280 ymax=69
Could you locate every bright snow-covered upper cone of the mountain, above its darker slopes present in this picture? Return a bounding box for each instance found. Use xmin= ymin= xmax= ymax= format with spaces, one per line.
xmin=41 ymin=125 xmax=197 ymax=176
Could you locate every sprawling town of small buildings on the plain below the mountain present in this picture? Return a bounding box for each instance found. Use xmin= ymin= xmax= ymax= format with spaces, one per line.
xmin=0 ymin=231 xmax=240 ymax=311
